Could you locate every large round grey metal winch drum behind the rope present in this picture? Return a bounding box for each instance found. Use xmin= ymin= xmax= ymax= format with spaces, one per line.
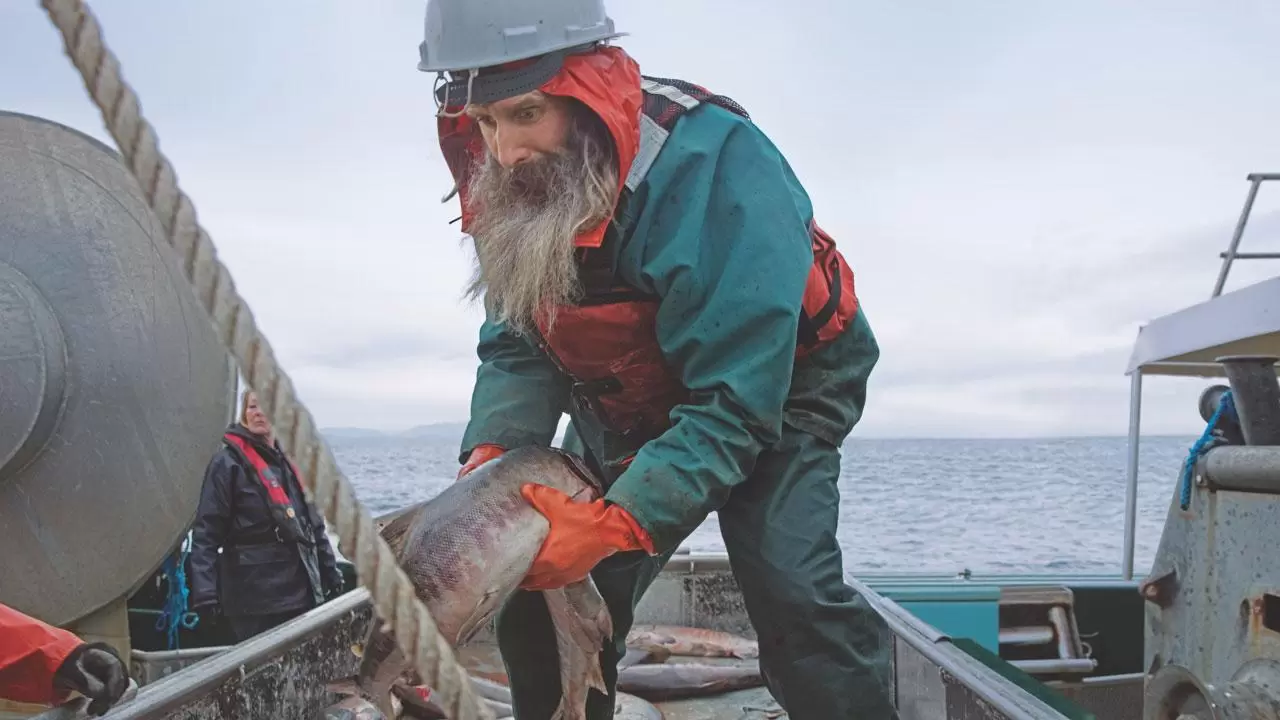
xmin=0 ymin=111 xmax=236 ymax=625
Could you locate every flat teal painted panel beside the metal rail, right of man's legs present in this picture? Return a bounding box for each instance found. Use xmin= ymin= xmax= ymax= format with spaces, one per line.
xmin=874 ymin=583 xmax=1000 ymax=655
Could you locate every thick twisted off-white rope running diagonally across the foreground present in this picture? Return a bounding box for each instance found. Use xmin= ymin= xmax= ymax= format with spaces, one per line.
xmin=41 ymin=0 xmax=494 ymax=720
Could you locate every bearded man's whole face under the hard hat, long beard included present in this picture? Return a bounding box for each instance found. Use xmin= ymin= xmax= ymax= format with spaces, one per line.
xmin=466 ymin=92 xmax=618 ymax=333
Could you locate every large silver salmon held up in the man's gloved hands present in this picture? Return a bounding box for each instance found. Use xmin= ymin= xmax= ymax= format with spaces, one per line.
xmin=356 ymin=447 xmax=613 ymax=720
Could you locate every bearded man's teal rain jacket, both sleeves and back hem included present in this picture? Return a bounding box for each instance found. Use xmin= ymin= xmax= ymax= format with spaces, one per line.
xmin=445 ymin=49 xmax=878 ymax=553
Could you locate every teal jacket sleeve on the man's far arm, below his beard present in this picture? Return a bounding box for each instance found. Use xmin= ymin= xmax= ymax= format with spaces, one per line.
xmin=460 ymin=311 xmax=570 ymax=462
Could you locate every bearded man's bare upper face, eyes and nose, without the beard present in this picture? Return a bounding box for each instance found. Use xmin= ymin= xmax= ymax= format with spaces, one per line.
xmin=467 ymin=91 xmax=573 ymax=169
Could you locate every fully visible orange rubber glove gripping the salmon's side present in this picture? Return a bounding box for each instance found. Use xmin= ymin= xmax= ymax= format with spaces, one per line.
xmin=520 ymin=484 xmax=654 ymax=591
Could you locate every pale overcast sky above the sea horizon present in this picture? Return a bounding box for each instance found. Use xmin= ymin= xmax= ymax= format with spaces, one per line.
xmin=0 ymin=0 xmax=1280 ymax=437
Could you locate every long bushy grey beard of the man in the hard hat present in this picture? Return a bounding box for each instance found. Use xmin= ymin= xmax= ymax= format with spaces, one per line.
xmin=466 ymin=121 xmax=618 ymax=334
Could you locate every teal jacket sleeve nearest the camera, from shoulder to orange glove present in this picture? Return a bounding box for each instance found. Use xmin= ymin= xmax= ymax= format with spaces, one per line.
xmin=607 ymin=106 xmax=813 ymax=553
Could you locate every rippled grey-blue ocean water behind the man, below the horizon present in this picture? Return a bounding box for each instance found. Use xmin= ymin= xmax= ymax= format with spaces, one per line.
xmin=330 ymin=437 xmax=1194 ymax=575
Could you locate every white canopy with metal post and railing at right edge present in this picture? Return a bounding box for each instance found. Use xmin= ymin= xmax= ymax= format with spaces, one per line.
xmin=1123 ymin=173 xmax=1280 ymax=580
